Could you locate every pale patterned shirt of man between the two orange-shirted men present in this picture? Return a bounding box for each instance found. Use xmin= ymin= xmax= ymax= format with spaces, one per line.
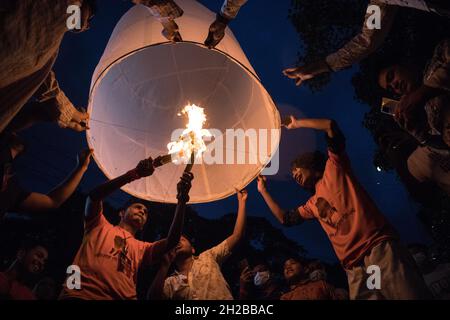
xmin=163 ymin=240 xmax=233 ymax=300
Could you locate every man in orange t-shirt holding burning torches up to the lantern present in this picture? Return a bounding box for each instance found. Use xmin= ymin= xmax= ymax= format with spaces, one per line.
xmin=60 ymin=158 xmax=193 ymax=300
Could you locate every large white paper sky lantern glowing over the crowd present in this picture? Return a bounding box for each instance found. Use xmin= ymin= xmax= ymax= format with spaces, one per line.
xmin=87 ymin=0 xmax=280 ymax=203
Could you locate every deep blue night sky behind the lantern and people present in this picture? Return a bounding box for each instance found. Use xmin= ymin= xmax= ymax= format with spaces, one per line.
xmin=13 ymin=0 xmax=430 ymax=262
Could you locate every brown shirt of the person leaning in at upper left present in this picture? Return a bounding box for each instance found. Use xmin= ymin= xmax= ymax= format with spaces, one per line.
xmin=0 ymin=0 xmax=81 ymax=132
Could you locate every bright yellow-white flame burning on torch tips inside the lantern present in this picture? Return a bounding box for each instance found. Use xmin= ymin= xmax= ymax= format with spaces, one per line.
xmin=155 ymin=104 xmax=212 ymax=171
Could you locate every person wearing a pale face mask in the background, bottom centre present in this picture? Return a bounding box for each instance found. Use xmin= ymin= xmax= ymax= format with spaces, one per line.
xmin=239 ymin=263 xmax=281 ymax=300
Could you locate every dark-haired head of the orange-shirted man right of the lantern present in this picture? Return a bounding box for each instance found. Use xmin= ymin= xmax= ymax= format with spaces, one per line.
xmin=291 ymin=151 xmax=327 ymax=191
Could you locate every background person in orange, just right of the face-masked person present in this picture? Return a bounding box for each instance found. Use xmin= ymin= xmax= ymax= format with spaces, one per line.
xmin=280 ymin=257 xmax=339 ymax=300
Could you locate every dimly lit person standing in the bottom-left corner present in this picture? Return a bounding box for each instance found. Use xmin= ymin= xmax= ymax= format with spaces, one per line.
xmin=0 ymin=239 xmax=48 ymax=300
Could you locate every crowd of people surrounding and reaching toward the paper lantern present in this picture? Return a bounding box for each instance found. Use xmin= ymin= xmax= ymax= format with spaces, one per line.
xmin=0 ymin=0 xmax=450 ymax=300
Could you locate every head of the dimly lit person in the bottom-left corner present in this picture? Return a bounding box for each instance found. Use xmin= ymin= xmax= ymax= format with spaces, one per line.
xmin=16 ymin=239 xmax=48 ymax=276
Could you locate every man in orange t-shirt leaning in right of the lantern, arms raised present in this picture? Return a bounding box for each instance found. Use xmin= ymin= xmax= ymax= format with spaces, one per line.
xmin=258 ymin=116 xmax=430 ymax=299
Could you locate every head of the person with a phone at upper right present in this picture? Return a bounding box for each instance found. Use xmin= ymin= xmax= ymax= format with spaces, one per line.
xmin=378 ymin=64 xmax=421 ymax=96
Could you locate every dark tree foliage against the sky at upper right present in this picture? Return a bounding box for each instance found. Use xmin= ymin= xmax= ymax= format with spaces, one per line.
xmin=289 ymin=0 xmax=450 ymax=260
